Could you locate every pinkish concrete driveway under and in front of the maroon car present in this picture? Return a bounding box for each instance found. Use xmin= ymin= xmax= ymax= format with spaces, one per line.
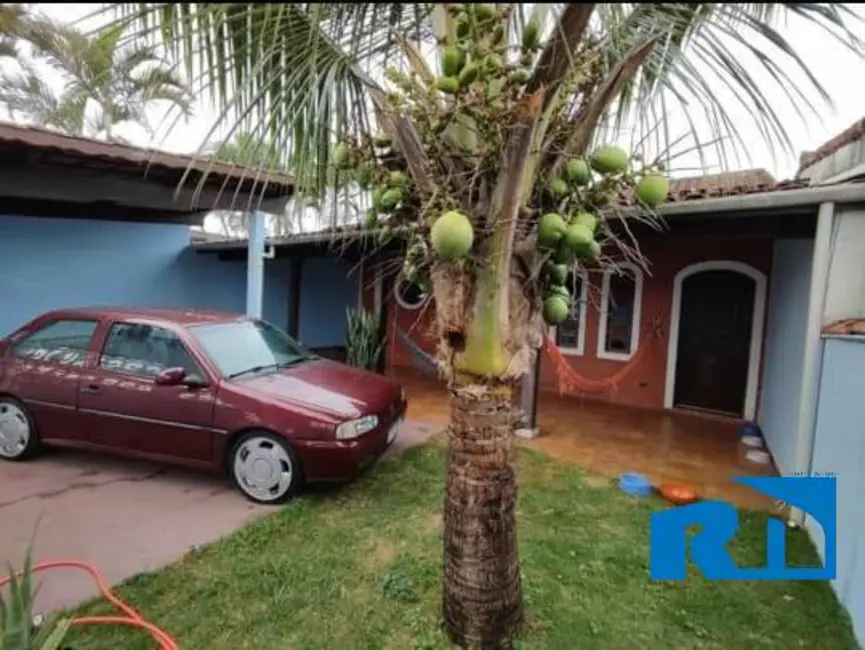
xmin=0 ymin=421 xmax=440 ymax=613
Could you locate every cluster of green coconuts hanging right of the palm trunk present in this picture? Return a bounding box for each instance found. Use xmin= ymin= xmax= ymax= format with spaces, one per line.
xmin=536 ymin=145 xmax=670 ymax=325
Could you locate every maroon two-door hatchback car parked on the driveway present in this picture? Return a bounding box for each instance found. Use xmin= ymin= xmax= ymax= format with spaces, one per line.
xmin=0 ymin=308 xmax=406 ymax=503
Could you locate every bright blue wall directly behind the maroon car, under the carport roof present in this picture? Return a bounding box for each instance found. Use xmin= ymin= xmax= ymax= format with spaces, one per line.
xmin=0 ymin=215 xmax=292 ymax=336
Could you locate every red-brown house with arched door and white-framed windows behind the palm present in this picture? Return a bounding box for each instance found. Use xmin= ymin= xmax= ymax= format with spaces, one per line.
xmin=194 ymin=115 xmax=865 ymax=486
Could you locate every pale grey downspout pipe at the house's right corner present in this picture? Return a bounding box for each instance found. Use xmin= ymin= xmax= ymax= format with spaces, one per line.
xmin=790 ymin=202 xmax=835 ymax=526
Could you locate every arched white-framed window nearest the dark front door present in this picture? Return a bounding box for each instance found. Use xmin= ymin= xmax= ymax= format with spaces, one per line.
xmin=598 ymin=262 xmax=643 ymax=361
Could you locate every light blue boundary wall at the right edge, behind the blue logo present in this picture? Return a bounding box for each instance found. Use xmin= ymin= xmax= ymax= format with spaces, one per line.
xmin=807 ymin=337 xmax=865 ymax=646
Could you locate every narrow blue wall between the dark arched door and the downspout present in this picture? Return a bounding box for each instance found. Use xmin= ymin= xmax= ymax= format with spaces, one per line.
xmin=757 ymin=239 xmax=814 ymax=474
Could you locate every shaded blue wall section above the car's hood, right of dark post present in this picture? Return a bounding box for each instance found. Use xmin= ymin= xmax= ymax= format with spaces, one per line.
xmin=298 ymin=255 xmax=358 ymax=348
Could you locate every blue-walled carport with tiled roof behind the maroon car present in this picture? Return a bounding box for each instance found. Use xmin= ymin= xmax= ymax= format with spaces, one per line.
xmin=0 ymin=123 xmax=356 ymax=354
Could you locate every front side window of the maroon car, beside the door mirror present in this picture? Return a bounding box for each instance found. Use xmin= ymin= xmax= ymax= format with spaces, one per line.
xmin=99 ymin=323 xmax=203 ymax=378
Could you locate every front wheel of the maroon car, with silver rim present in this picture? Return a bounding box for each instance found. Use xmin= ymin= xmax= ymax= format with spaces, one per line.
xmin=229 ymin=431 xmax=300 ymax=505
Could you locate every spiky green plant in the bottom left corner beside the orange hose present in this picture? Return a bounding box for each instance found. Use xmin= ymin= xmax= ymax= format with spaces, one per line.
xmin=0 ymin=551 xmax=72 ymax=650
